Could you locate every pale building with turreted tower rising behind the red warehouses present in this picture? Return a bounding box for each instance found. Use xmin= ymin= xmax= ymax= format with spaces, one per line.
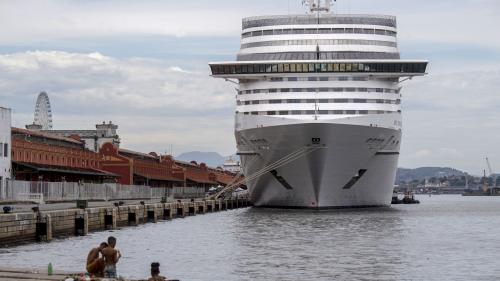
xmin=42 ymin=121 xmax=120 ymax=153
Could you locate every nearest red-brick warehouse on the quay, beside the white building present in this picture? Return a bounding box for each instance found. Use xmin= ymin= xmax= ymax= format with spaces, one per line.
xmin=11 ymin=128 xmax=118 ymax=183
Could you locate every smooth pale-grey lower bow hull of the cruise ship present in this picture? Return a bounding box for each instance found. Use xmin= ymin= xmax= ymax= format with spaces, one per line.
xmin=236 ymin=114 xmax=401 ymax=209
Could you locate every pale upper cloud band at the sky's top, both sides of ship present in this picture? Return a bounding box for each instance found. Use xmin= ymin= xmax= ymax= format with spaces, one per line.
xmin=0 ymin=0 xmax=500 ymax=48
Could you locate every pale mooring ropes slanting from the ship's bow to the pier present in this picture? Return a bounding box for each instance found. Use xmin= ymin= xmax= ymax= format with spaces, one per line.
xmin=208 ymin=145 xmax=327 ymax=199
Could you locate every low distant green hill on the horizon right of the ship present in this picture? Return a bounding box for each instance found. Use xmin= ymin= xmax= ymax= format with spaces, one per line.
xmin=396 ymin=167 xmax=466 ymax=183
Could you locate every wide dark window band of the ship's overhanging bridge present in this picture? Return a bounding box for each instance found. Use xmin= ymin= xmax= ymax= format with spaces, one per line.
xmin=210 ymin=62 xmax=427 ymax=75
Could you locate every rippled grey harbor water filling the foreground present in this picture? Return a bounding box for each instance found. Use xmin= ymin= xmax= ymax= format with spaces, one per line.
xmin=0 ymin=195 xmax=500 ymax=280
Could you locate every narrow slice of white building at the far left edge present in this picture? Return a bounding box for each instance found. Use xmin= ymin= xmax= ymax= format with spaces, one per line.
xmin=0 ymin=107 xmax=11 ymax=194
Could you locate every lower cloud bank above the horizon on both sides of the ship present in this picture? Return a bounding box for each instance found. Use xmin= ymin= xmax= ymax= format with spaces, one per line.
xmin=0 ymin=51 xmax=500 ymax=174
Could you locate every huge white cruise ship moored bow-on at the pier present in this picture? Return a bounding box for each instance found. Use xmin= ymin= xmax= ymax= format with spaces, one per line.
xmin=210 ymin=0 xmax=428 ymax=209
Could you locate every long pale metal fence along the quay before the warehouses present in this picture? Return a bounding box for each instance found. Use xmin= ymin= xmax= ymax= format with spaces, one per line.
xmin=0 ymin=180 xmax=205 ymax=202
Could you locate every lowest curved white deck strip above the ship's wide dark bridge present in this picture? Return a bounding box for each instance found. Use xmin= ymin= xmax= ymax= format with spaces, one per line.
xmin=241 ymin=39 xmax=397 ymax=49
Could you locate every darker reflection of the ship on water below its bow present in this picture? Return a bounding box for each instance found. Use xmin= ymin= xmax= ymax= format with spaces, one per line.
xmin=234 ymin=208 xmax=405 ymax=280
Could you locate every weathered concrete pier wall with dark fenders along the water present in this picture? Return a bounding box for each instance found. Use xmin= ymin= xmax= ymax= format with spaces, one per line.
xmin=0 ymin=199 xmax=251 ymax=245
